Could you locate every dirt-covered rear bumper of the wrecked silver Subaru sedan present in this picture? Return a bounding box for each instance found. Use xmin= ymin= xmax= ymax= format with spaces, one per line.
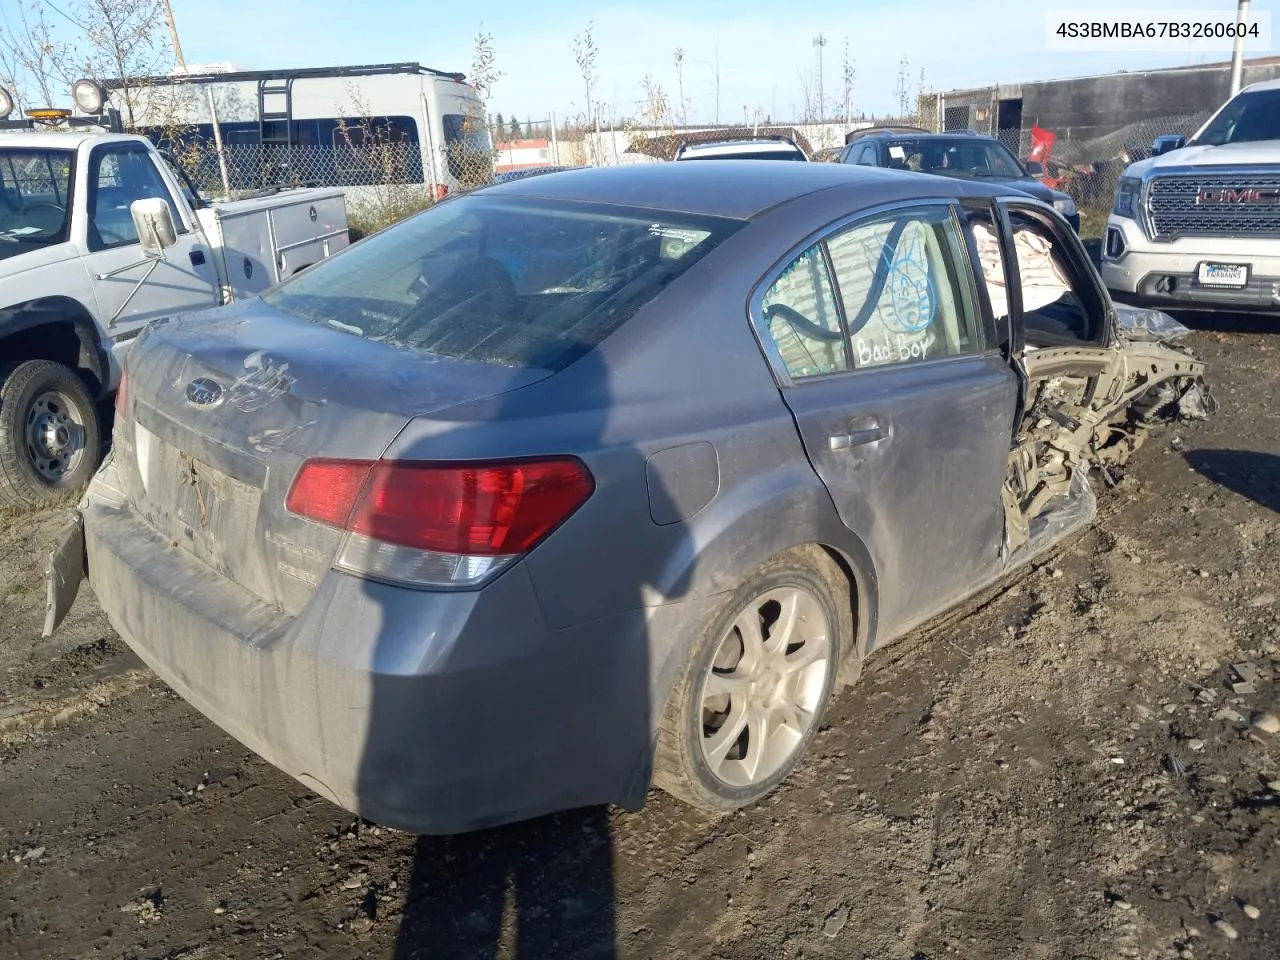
xmin=82 ymin=458 xmax=698 ymax=833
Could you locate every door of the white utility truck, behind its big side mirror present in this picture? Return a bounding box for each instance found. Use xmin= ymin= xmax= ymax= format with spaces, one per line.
xmin=83 ymin=142 xmax=218 ymax=340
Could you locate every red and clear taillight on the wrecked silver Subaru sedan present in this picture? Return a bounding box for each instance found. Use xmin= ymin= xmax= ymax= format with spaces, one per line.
xmin=285 ymin=457 xmax=595 ymax=586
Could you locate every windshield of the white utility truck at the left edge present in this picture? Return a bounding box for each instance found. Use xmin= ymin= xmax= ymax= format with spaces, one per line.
xmin=0 ymin=148 xmax=76 ymax=260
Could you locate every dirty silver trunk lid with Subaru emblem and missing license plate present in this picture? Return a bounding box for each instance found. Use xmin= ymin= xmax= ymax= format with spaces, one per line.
xmin=116 ymin=301 xmax=549 ymax=614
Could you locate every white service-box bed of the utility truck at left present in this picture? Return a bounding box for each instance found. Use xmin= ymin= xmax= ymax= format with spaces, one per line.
xmin=197 ymin=188 xmax=349 ymax=301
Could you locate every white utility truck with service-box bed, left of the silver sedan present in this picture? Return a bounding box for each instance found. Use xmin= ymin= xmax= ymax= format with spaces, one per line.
xmin=0 ymin=120 xmax=348 ymax=506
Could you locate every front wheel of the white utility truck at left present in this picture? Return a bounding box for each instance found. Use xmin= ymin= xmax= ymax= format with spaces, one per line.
xmin=0 ymin=360 xmax=102 ymax=507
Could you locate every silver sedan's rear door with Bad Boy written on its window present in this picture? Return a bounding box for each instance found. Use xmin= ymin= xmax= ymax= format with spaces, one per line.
xmin=753 ymin=201 xmax=1019 ymax=636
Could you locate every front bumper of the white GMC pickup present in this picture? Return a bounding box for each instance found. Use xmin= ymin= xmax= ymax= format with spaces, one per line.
xmin=1101 ymin=216 xmax=1280 ymax=312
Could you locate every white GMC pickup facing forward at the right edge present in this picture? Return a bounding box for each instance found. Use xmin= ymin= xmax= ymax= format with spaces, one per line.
xmin=1102 ymin=81 xmax=1280 ymax=312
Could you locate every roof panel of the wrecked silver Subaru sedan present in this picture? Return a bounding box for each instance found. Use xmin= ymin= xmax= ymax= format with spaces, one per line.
xmin=476 ymin=160 xmax=1025 ymax=220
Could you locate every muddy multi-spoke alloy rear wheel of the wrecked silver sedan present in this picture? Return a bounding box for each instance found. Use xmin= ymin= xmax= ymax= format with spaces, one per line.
xmin=654 ymin=550 xmax=852 ymax=813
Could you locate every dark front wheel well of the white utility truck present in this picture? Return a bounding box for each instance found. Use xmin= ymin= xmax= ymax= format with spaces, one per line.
xmin=0 ymin=297 xmax=108 ymax=397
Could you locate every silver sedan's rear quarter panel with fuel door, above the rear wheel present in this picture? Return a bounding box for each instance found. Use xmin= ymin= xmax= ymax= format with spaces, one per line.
xmin=373 ymin=178 xmax=950 ymax=675
